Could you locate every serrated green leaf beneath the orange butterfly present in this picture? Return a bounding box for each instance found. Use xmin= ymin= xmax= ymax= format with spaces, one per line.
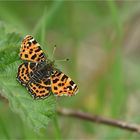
xmin=0 ymin=28 xmax=56 ymax=132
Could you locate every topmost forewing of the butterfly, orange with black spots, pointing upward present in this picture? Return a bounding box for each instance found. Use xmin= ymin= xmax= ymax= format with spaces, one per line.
xmin=20 ymin=35 xmax=46 ymax=62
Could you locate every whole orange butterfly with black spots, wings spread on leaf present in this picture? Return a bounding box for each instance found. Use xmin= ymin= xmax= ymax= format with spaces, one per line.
xmin=17 ymin=35 xmax=78 ymax=99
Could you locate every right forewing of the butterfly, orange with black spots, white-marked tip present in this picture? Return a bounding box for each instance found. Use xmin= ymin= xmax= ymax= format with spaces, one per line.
xmin=51 ymin=70 xmax=78 ymax=96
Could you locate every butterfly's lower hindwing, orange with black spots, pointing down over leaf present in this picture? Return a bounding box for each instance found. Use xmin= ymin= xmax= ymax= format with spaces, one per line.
xmin=27 ymin=77 xmax=51 ymax=99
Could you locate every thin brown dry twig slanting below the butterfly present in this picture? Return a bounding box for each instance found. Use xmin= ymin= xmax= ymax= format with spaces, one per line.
xmin=57 ymin=108 xmax=140 ymax=133
